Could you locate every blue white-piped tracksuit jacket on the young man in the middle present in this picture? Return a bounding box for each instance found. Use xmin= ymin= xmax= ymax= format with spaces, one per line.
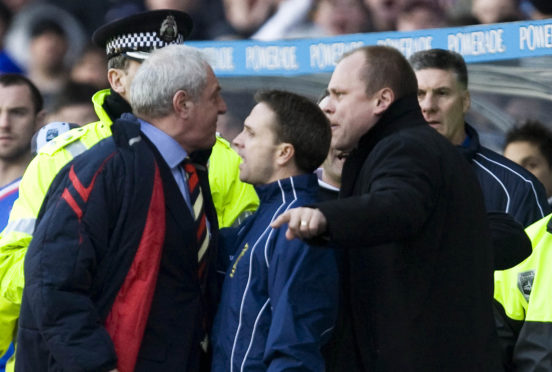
xmin=212 ymin=174 xmax=338 ymax=372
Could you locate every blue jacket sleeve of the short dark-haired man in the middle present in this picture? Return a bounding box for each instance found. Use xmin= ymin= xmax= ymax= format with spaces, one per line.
xmin=264 ymin=227 xmax=338 ymax=372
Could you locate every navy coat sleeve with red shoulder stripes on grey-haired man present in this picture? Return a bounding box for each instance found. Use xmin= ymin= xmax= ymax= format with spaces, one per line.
xmin=21 ymin=162 xmax=118 ymax=371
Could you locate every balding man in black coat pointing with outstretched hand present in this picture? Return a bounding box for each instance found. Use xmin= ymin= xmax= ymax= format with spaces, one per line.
xmin=272 ymin=46 xmax=500 ymax=372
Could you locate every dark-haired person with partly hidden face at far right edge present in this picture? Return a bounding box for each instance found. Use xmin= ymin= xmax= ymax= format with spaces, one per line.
xmin=504 ymin=121 xmax=552 ymax=204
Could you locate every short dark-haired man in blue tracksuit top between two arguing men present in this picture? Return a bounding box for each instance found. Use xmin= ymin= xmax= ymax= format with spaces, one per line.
xmin=212 ymin=91 xmax=338 ymax=372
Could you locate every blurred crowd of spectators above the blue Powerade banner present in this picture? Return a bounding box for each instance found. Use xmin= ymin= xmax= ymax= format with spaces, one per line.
xmin=0 ymin=0 xmax=552 ymax=124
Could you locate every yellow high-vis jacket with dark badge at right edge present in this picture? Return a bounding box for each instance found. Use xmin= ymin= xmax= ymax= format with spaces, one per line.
xmin=494 ymin=214 xmax=552 ymax=372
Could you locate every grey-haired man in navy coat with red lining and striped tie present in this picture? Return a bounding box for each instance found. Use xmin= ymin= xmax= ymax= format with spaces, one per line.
xmin=16 ymin=45 xmax=226 ymax=371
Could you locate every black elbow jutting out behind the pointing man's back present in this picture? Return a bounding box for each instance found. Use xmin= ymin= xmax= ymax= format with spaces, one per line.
xmin=487 ymin=212 xmax=533 ymax=270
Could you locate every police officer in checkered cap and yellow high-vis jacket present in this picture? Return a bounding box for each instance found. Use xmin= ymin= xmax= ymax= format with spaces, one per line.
xmin=0 ymin=10 xmax=259 ymax=368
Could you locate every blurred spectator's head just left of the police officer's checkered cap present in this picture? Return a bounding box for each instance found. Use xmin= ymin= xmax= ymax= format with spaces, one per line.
xmin=71 ymin=43 xmax=109 ymax=90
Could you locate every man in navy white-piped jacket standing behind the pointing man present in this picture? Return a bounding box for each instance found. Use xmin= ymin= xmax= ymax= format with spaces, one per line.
xmin=410 ymin=49 xmax=550 ymax=227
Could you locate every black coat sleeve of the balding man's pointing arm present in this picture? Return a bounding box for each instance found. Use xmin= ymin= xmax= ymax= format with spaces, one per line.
xmin=316 ymin=139 xmax=443 ymax=246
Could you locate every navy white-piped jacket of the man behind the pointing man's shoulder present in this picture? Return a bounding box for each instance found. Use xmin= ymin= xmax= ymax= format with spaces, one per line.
xmin=458 ymin=123 xmax=550 ymax=227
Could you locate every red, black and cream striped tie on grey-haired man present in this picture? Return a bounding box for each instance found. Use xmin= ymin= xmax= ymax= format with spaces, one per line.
xmin=183 ymin=158 xmax=209 ymax=282
